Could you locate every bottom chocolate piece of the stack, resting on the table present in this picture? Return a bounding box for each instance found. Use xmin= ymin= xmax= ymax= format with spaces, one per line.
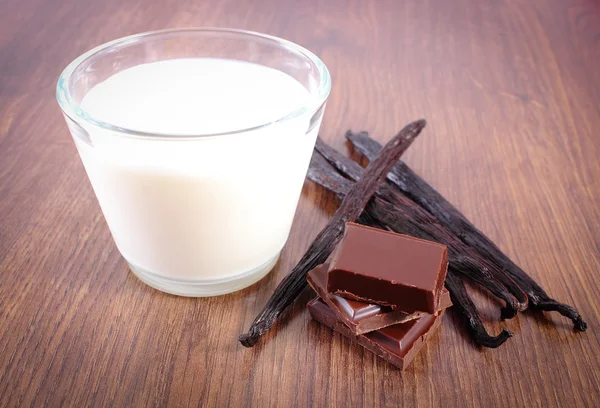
xmin=307 ymin=298 xmax=444 ymax=370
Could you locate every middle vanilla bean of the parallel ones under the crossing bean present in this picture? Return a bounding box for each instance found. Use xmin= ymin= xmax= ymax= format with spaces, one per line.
xmin=316 ymin=139 xmax=527 ymax=319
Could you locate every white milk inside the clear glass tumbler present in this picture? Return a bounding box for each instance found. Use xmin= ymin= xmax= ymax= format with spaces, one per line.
xmin=74 ymin=58 xmax=319 ymax=295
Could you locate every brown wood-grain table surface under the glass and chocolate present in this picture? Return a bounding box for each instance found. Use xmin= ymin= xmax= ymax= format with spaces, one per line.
xmin=0 ymin=0 xmax=600 ymax=407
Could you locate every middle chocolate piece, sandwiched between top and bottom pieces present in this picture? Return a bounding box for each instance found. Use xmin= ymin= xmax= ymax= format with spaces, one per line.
xmin=306 ymin=265 xmax=452 ymax=334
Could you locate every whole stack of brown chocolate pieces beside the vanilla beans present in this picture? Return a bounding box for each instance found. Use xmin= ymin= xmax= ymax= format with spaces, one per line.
xmin=307 ymin=223 xmax=452 ymax=369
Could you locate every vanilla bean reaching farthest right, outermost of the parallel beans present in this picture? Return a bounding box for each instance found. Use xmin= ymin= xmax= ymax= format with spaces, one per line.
xmin=346 ymin=131 xmax=587 ymax=331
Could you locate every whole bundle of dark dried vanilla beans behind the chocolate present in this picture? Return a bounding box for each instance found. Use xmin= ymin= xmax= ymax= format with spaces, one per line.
xmin=239 ymin=120 xmax=587 ymax=348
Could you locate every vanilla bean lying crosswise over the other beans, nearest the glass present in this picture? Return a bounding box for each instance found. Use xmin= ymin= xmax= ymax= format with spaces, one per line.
xmin=239 ymin=120 xmax=425 ymax=347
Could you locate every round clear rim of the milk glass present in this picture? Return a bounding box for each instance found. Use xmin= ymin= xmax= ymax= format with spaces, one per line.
xmin=56 ymin=27 xmax=331 ymax=139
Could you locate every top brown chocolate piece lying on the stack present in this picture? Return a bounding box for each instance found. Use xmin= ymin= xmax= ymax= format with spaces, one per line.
xmin=327 ymin=222 xmax=448 ymax=314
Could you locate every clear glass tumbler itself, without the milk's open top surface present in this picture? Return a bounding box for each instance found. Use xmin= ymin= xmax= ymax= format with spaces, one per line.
xmin=56 ymin=28 xmax=331 ymax=296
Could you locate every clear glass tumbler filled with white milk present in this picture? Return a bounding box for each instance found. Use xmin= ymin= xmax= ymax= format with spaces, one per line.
xmin=57 ymin=29 xmax=331 ymax=296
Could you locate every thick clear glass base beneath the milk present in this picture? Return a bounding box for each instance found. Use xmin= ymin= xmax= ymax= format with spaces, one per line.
xmin=127 ymin=252 xmax=281 ymax=297
